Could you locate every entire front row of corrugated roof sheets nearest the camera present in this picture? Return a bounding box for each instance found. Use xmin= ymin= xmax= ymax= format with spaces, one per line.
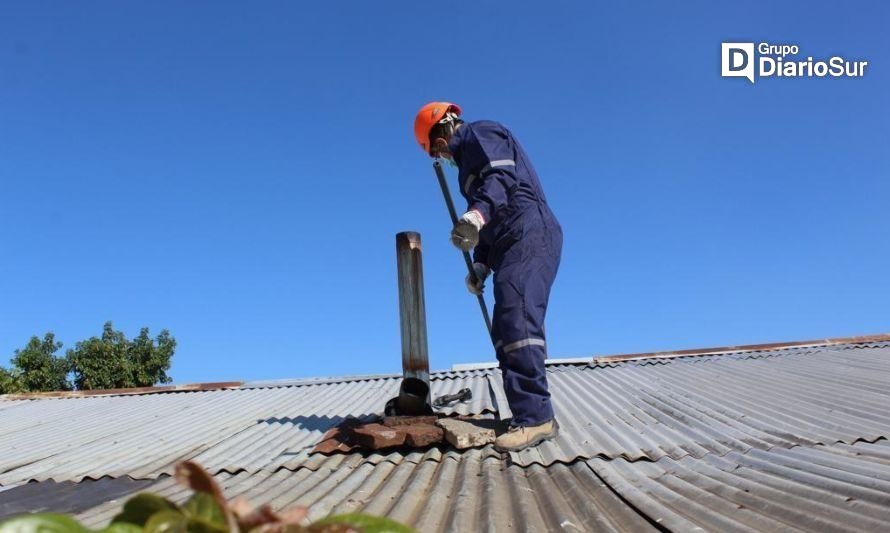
xmin=57 ymin=440 xmax=890 ymax=532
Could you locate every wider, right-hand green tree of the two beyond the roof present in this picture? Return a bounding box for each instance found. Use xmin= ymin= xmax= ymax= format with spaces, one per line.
xmin=67 ymin=322 xmax=176 ymax=390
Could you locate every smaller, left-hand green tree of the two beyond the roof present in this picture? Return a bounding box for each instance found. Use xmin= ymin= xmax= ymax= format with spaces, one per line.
xmin=12 ymin=333 xmax=71 ymax=392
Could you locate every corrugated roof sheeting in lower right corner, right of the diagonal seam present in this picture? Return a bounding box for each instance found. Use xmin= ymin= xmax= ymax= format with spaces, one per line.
xmin=588 ymin=440 xmax=890 ymax=531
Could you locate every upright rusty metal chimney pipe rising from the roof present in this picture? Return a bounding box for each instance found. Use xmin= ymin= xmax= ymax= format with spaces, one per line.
xmin=396 ymin=231 xmax=432 ymax=415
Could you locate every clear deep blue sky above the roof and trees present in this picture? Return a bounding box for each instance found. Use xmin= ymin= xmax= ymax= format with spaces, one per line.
xmin=0 ymin=0 xmax=890 ymax=383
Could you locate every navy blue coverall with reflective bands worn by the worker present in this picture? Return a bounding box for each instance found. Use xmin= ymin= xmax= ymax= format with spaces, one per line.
xmin=448 ymin=120 xmax=562 ymax=427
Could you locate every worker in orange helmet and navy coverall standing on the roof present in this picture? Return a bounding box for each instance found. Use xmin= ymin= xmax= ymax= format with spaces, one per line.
xmin=414 ymin=102 xmax=562 ymax=451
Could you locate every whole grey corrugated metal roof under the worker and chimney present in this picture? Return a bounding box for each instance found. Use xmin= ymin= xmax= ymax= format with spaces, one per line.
xmin=0 ymin=342 xmax=890 ymax=531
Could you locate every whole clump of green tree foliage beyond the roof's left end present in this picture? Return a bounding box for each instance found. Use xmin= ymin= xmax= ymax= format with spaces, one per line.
xmin=0 ymin=322 xmax=176 ymax=394
